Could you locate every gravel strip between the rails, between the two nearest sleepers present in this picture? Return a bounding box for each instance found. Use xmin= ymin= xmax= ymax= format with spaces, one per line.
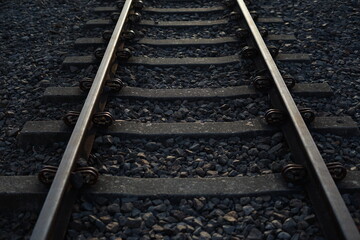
xmin=93 ymin=133 xmax=292 ymax=178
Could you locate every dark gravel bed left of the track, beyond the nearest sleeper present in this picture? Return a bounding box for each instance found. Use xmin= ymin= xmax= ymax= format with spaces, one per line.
xmin=0 ymin=0 xmax=98 ymax=175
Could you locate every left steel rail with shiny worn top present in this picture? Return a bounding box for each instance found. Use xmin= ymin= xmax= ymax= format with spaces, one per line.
xmin=31 ymin=0 xmax=132 ymax=240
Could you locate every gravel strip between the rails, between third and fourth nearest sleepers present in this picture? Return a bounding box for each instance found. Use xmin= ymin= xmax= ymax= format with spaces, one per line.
xmin=117 ymin=63 xmax=250 ymax=88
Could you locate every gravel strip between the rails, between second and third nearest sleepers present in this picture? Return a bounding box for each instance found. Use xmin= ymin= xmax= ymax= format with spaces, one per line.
xmin=107 ymin=97 xmax=269 ymax=122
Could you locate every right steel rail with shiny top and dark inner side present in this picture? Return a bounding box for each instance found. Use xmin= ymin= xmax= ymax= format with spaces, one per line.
xmin=237 ymin=0 xmax=360 ymax=240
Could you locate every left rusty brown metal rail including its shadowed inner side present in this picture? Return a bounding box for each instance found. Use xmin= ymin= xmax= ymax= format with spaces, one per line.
xmin=31 ymin=0 xmax=132 ymax=240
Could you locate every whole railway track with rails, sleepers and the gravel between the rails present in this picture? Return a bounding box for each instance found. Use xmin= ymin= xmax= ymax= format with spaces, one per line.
xmin=1 ymin=0 xmax=359 ymax=239
